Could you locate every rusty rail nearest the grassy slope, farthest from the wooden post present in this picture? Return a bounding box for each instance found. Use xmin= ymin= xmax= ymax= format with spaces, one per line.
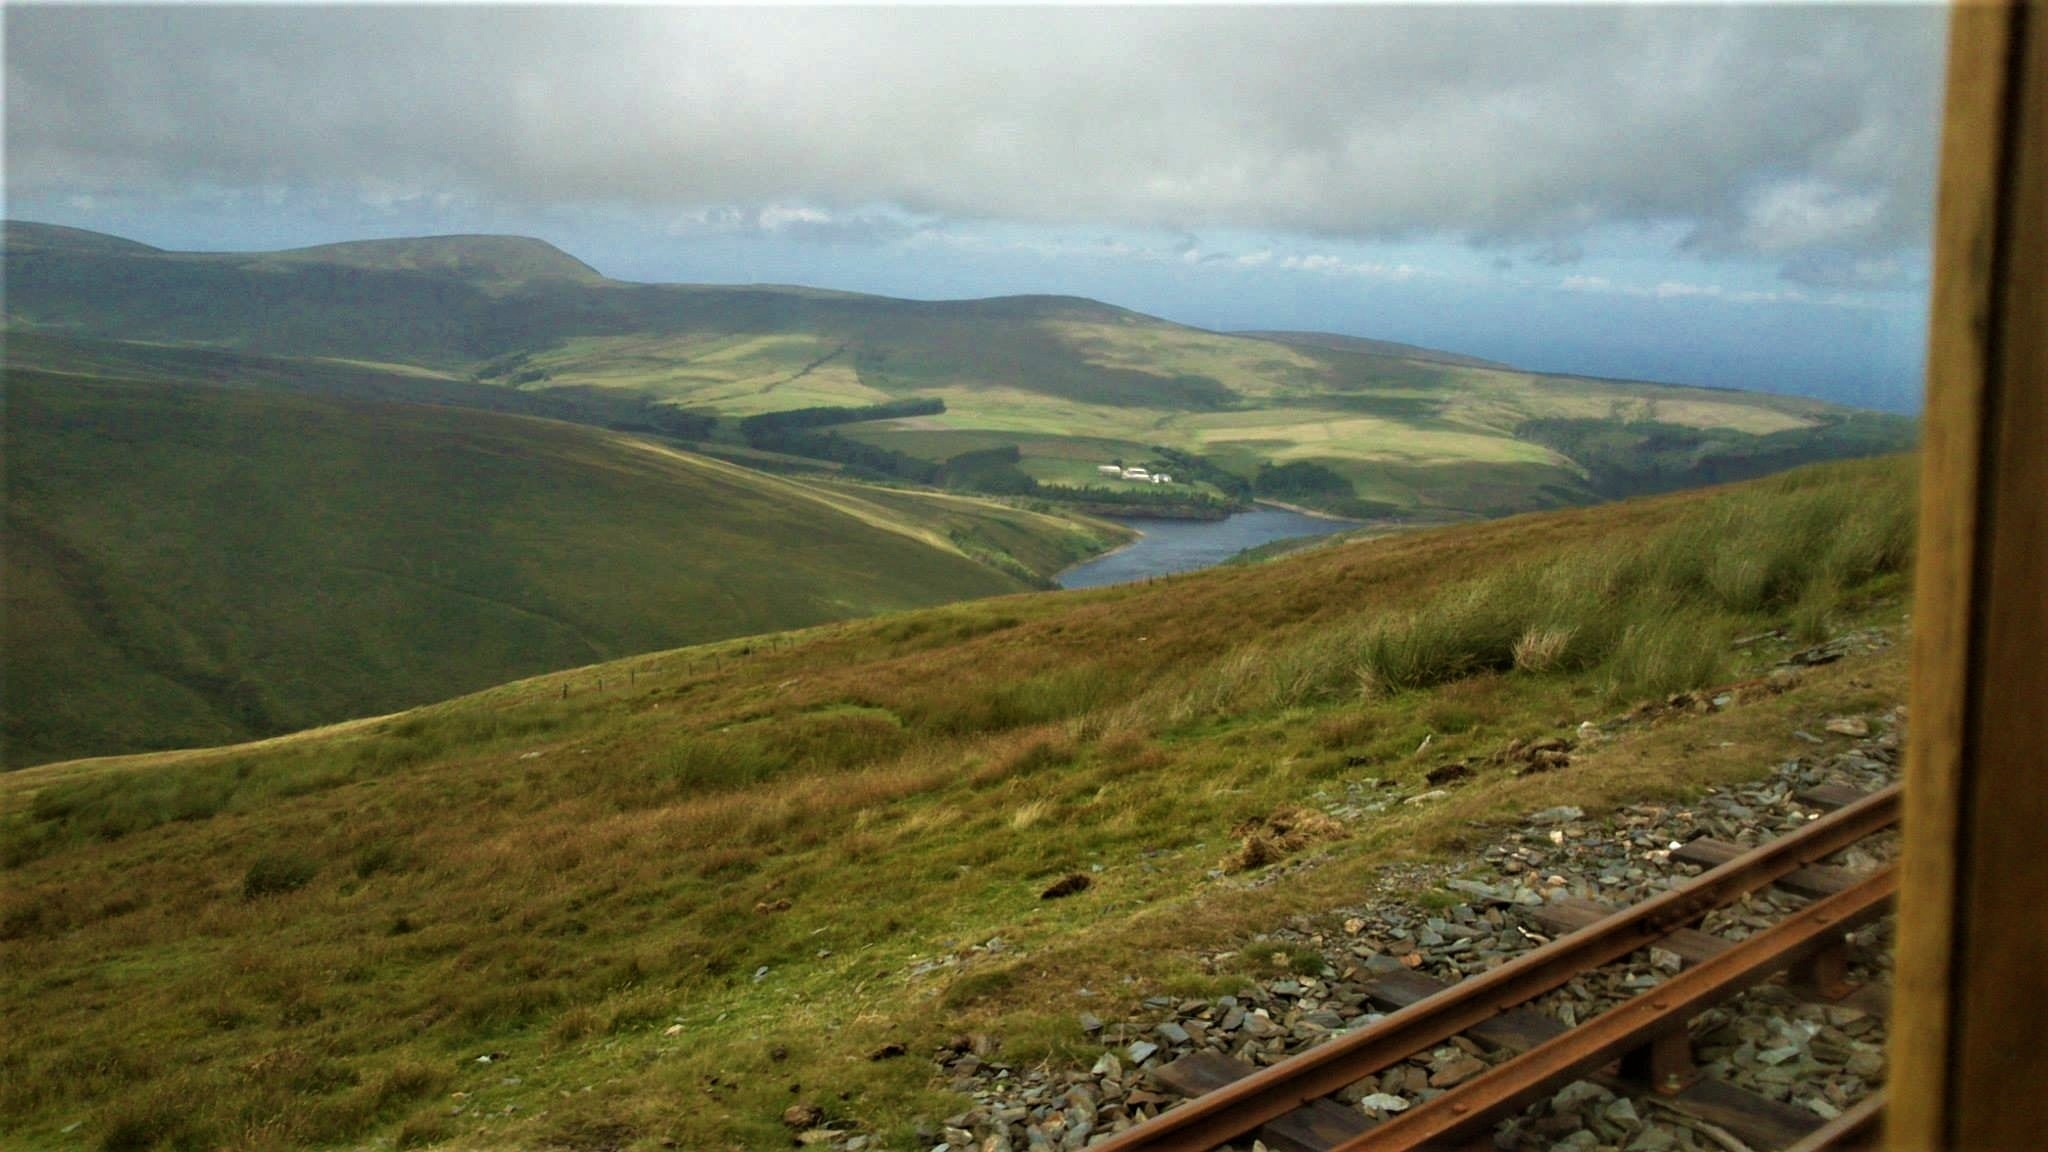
xmin=1096 ymin=785 xmax=1898 ymax=1152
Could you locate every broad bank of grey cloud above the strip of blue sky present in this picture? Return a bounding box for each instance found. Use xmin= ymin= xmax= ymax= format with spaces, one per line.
xmin=6 ymin=6 xmax=1944 ymax=262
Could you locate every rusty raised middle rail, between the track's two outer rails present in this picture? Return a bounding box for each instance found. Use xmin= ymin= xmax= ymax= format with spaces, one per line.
xmin=1331 ymin=867 xmax=1898 ymax=1152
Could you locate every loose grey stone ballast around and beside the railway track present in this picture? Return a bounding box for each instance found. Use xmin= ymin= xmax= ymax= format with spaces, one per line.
xmin=880 ymin=701 xmax=1901 ymax=1152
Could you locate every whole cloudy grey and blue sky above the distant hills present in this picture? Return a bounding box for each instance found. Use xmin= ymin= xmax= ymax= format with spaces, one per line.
xmin=4 ymin=4 xmax=1944 ymax=408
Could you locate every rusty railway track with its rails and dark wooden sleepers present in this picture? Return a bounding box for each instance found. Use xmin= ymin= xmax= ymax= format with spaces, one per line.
xmin=1096 ymin=785 xmax=1898 ymax=1152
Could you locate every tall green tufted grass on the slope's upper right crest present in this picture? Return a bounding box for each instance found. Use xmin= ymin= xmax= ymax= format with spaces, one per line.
xmin=1165 ymin=459 xmax=1915 ymax=722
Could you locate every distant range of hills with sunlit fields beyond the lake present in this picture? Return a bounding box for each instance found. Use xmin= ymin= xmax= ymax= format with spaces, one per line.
xmin=6 ymin=223 xmax=1913 ymax=519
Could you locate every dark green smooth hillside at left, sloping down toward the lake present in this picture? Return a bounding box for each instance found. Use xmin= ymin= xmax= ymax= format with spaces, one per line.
xmin=6 ymin=366 xmax=1120 ymax=767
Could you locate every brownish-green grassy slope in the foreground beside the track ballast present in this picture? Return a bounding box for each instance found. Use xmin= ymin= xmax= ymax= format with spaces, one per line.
xmin=0 ymin=459 xmax=1913 ymax=1150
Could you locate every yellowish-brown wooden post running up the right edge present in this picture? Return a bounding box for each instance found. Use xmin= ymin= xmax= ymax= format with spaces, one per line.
xmin=1886 ymin=0 xmax=2048 ymax=1152
